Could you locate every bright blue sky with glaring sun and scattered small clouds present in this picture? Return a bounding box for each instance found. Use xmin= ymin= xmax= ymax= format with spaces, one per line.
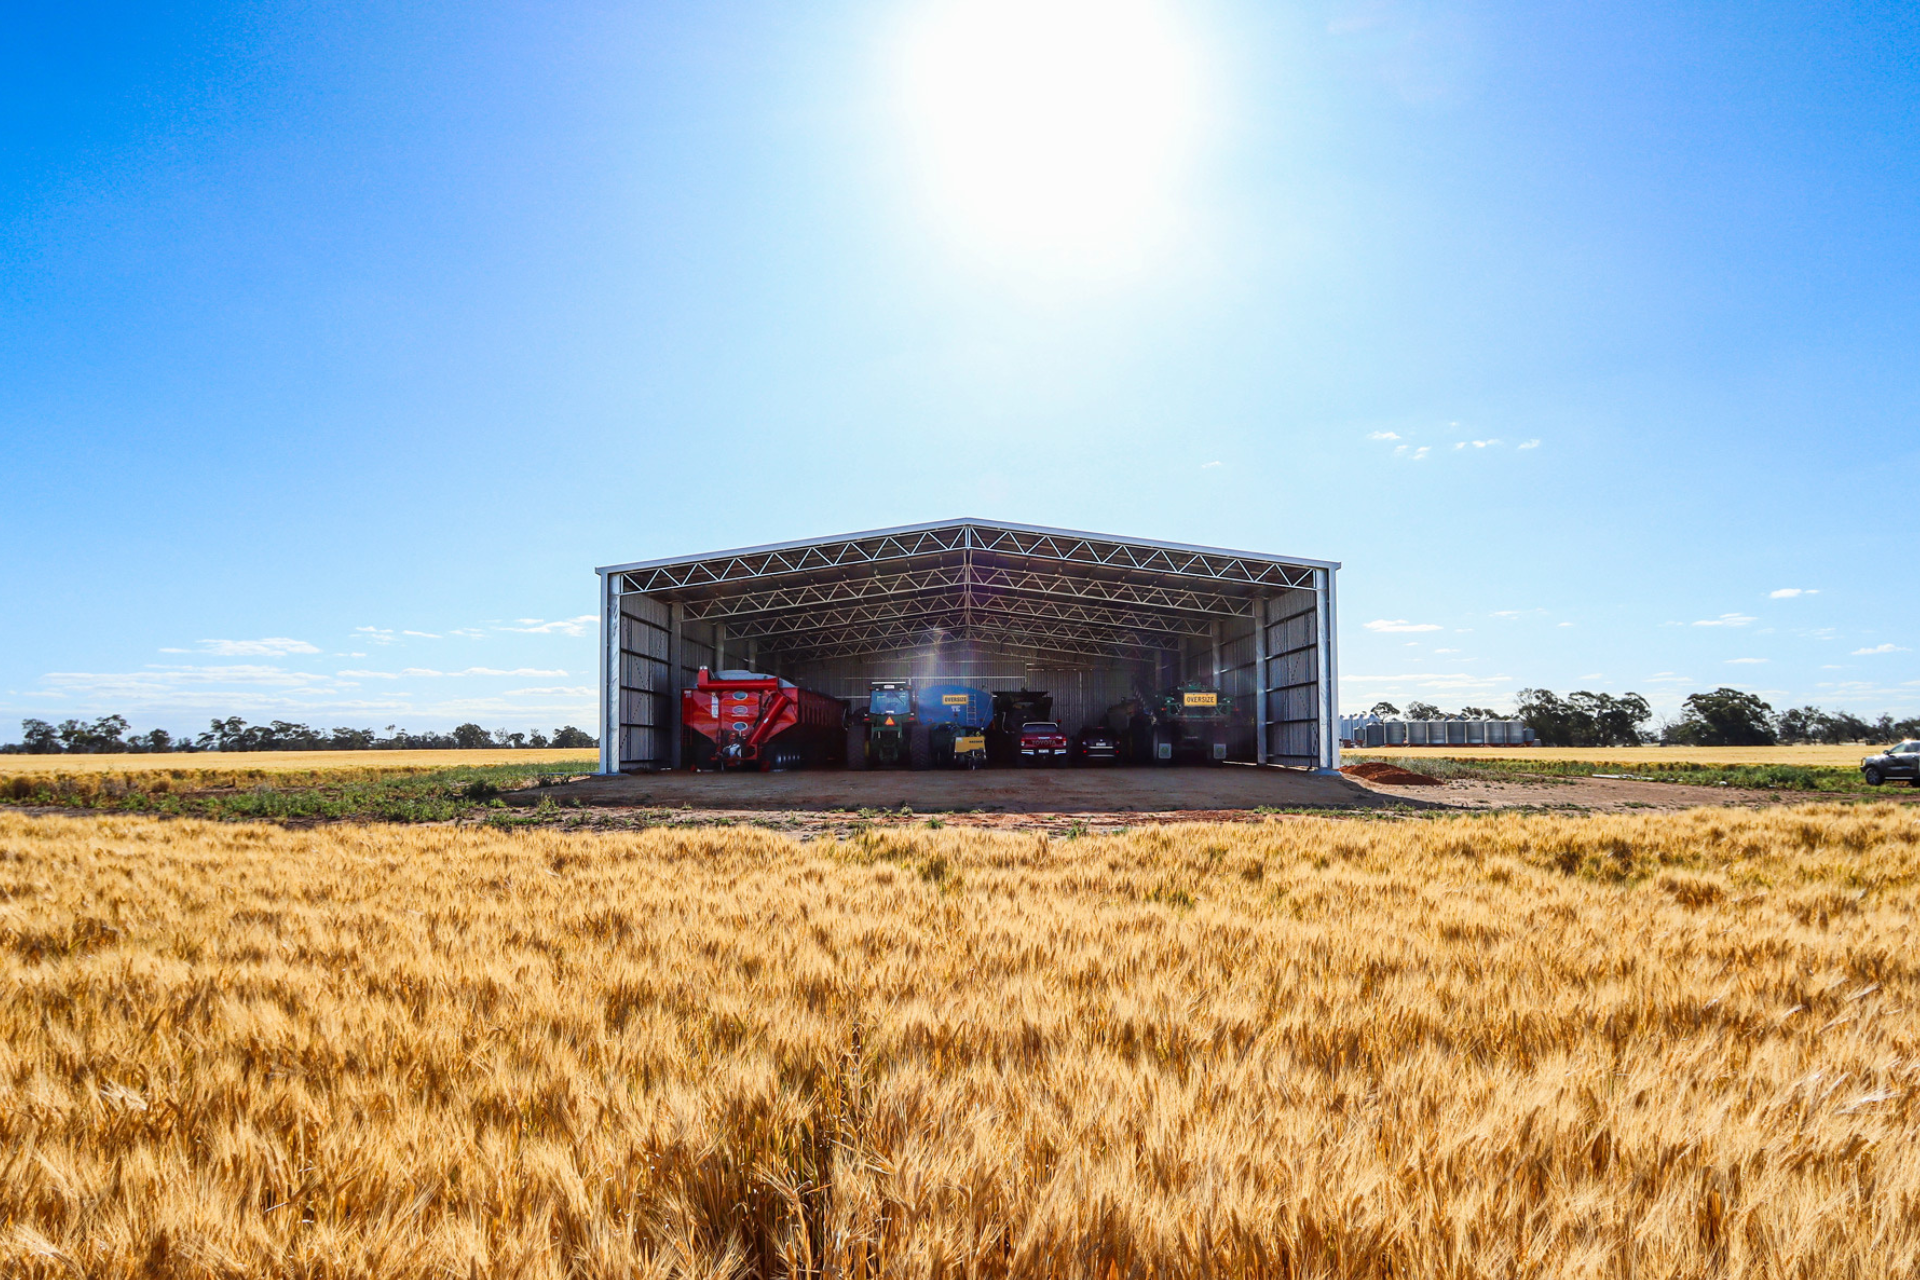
xmin=0 ymin=0 xmax=1920 ymax=737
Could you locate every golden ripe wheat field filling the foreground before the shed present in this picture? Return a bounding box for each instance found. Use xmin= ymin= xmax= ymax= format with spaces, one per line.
xmin=0 ymin=804 xmax=1920 ymax=1280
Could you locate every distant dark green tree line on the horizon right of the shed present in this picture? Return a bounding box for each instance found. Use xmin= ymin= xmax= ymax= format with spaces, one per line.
xmin=1373 ymin=687 xmax=1920 ymax=747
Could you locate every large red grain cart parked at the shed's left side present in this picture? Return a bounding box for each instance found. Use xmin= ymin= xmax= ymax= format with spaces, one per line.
xmin=680 ymin=666 xmax=847 ymax=771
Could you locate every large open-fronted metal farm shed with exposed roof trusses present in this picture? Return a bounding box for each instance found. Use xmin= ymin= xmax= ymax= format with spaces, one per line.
xmin=597 ymin=520 xmax=1340 ymax=773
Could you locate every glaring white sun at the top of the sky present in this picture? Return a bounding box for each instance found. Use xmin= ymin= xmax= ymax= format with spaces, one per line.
xmin=902 ymin=0 xmax=1198 ymax=269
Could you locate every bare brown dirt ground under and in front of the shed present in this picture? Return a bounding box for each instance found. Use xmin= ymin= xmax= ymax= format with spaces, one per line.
xmin=507 ymin=764 xmax=1920 ymax=839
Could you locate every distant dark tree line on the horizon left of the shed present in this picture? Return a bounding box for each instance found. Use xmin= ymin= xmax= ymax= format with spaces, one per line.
xmin=0 ymin=716 xmax=599 ymax=756
